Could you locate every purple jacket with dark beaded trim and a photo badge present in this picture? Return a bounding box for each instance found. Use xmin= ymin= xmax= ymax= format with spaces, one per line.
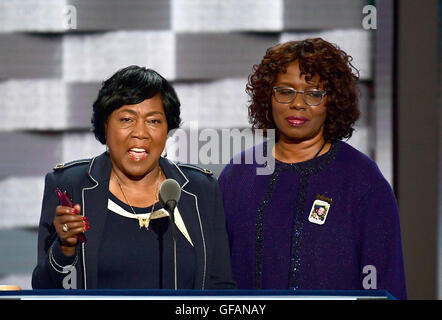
xmin=219 ymin=141 xmax=407 ymax=299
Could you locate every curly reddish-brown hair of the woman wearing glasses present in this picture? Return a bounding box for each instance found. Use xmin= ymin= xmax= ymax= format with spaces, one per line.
xmin=246 ymin=38 xmax=360 ymax=141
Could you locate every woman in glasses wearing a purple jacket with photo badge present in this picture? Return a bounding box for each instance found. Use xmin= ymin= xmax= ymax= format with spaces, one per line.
xmin=219 ymin=38 xmax=406 ymax=299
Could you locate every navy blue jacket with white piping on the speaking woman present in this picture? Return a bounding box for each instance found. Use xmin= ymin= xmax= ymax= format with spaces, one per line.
xmin=32 ymin=153 xmax=236 ymax=289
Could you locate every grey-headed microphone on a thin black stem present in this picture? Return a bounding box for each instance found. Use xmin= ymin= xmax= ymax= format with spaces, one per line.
xmin=158 ymin=179 xmax=181 ymax=290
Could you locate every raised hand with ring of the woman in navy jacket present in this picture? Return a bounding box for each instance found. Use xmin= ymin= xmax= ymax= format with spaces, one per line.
xmin=54 ymin=204 xmax=89 ymax=256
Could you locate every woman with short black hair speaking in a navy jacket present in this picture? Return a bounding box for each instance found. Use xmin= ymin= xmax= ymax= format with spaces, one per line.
xmin=32 ymin=66 xmax=235 ymax=289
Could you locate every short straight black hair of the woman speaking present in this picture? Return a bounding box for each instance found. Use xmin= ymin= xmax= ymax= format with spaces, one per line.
xmin=91 ymin=65 xmax=181 ymax=144
